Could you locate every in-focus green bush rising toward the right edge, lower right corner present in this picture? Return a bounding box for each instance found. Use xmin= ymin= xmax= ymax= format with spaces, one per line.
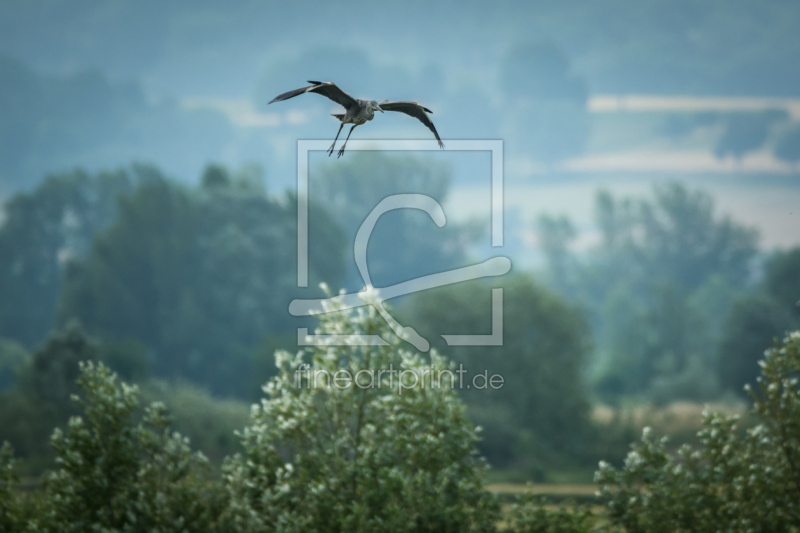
xmin=596 ymin=332 xmax=800 ymax=532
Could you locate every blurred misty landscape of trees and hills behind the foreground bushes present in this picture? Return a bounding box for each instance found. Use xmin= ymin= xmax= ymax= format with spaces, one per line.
xmin=0 ymin=0 xmax=800 ymax=481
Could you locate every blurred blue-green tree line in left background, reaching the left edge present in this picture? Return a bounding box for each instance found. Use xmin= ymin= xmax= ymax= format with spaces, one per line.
xmin=0 ymin=166 xmax=343 ymax=394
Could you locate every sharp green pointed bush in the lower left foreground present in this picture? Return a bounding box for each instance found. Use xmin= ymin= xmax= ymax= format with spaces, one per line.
xmin=36 ymin=362 xmax=220 ymax=532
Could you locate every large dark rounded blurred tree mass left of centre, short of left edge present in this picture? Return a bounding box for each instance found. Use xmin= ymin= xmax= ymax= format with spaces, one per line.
xmin=59 ymin=166 xmax=343 ymax=394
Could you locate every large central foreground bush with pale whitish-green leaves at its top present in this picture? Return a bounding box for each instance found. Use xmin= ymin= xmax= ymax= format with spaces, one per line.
xmin=223 ymin=296 xmax=499 ymax=532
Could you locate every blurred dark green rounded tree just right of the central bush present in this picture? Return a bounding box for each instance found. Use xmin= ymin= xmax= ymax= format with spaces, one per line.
xmin=403 ymin=275 xmax=591 ymax=480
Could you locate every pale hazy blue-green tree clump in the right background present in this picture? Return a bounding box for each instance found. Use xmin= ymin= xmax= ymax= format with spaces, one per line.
xmin=539 ymin=183 xmax=757 ymax=402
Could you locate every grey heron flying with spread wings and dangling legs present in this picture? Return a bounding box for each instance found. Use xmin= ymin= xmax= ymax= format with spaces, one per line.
xmin=270 ymin=81 xmax=444 ymax=157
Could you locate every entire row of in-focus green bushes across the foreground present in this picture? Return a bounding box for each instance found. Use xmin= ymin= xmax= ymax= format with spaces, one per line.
xmin=0 ymin=308 xmax=800 ymax=533
